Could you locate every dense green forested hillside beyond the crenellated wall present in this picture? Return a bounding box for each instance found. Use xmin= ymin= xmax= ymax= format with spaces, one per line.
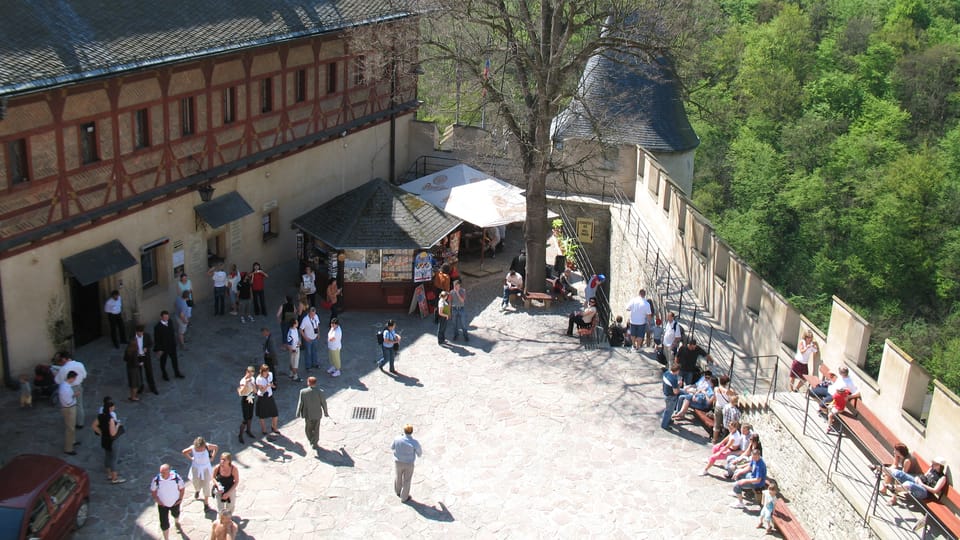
xmin=682 ymin=0 xmax=960 ymax=391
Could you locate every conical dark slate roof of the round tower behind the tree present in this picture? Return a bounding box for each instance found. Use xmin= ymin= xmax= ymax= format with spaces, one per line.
xmin=554 ymin=53 xmax=700 ymax=152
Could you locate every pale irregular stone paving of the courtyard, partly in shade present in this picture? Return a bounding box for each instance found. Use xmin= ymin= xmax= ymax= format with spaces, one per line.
xmin=0 ymin=258 xmax=763 ymax=540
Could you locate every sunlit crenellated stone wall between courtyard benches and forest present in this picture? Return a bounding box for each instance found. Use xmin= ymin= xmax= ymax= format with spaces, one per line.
xmin=610 ymin=150 xmax=960 ymax=466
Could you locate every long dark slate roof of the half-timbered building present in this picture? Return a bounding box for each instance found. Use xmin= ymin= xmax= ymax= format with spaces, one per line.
xmin=0 ymin=0 xmax=412 ymax=96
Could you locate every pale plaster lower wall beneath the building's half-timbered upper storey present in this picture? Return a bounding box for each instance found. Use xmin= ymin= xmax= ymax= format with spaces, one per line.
xmin=0 ymin=120 xmax=398 ymax=376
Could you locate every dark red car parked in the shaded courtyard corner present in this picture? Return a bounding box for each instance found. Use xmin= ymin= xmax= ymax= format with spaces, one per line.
xmin=0 ymin=455 xmax=90 ymax=540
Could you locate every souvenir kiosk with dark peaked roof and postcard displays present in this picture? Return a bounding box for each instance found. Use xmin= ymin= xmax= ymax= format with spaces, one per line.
xmin=292 ymin=179 xmax=461 ymax=310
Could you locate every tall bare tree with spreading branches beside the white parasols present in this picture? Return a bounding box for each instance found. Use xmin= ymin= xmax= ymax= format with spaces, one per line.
xmin=421 ymin=0 xmax=702 ymax=283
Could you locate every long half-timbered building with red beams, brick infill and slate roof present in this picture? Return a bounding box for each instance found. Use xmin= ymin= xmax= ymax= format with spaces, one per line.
xmin=0 ymin=0 xmax=416 ymax=382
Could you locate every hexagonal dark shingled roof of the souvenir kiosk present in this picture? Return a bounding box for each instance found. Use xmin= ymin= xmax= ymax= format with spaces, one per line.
xmin=292 ymin=178 xmax=463 ymax=249
